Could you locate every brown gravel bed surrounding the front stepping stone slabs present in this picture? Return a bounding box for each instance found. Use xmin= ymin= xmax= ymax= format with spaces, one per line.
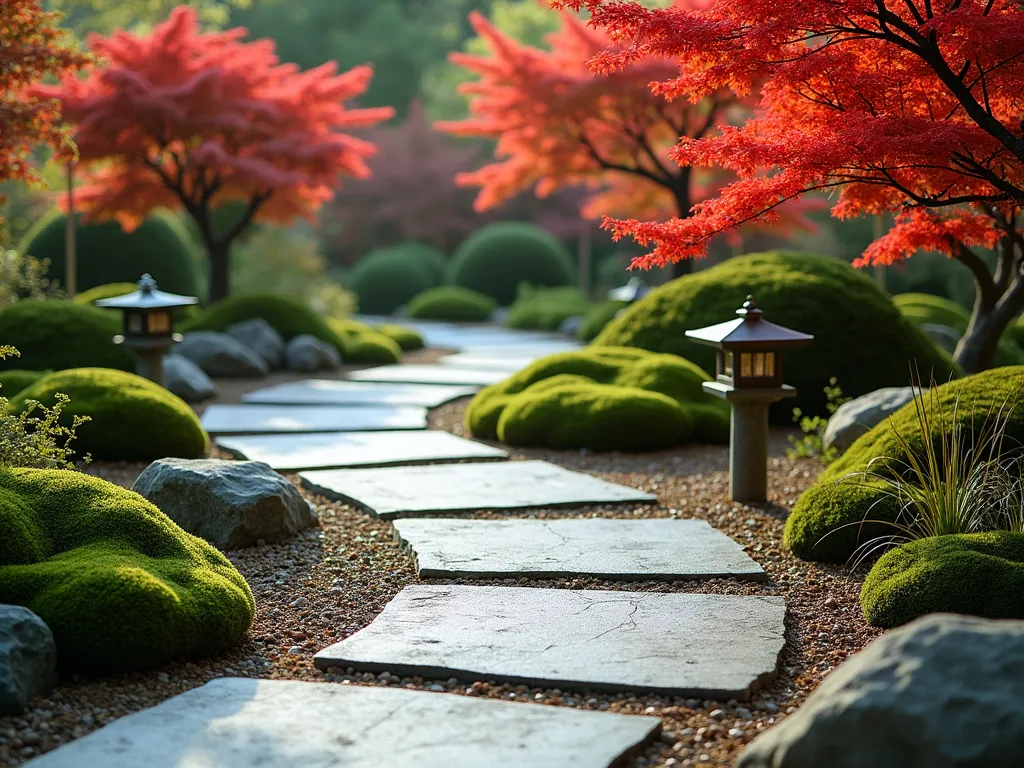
xmin=0 ymin=399 xmax=879 ymax=768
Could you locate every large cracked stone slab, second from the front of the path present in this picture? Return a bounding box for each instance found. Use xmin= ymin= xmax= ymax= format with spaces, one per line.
xmin=314 ymin=585 xmax=785 ymax=700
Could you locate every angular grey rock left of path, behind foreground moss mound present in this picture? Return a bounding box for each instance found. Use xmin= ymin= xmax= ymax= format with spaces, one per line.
xmin=132 ymin=459 xmax=316 ymax=550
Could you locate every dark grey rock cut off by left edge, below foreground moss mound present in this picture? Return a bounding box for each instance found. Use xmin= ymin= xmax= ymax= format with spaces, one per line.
xmin=0 ymin=605 xmax=57 ymax=715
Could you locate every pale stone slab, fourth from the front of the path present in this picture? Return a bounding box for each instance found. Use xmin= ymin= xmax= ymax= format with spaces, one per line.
xmin=300 ymin=461 xmax=656 ymax=520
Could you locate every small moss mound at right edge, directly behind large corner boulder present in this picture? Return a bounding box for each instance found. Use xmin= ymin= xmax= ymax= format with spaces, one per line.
xmin=860 ymin=530 xmax=1024 ymax=629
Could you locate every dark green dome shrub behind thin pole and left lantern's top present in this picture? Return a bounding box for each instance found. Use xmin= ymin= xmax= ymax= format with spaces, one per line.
xmin=18 ymin=211 xmax=200 ymax=296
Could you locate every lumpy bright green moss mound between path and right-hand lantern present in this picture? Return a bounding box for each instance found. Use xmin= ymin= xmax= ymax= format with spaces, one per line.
xmin=466 ymin=347 xmax=729 ymax=451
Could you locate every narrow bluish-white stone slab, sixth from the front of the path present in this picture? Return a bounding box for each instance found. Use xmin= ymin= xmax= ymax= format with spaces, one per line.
xmin=202 ymin=404 xmax=427 ymax=435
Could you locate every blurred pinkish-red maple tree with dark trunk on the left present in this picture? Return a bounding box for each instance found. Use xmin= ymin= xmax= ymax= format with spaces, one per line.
xmin=38 ymin=6 xmax=393 ymax=300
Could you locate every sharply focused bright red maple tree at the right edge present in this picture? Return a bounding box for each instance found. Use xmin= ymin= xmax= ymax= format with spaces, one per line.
xmin=552 ymin=0 xmax=1024 ymax=371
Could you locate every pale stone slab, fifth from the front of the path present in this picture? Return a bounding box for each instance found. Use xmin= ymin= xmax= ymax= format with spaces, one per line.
xmin=216 ymin=429 xmax=508 ymax=470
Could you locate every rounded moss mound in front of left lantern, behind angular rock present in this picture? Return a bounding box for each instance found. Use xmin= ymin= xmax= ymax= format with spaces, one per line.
xmin=10 ymin=368 xmax=209 ymax=461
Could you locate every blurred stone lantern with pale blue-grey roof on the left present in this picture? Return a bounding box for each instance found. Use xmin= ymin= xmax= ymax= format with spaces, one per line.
xmin=96 ymin=274 xmax=199 ymax=386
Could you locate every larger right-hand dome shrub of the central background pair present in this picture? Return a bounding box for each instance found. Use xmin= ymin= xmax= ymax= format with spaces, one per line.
xmin=447 ymin=221 xmax=575 ymax=306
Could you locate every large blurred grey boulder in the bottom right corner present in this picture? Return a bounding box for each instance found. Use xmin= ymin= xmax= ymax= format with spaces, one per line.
xmin=736 ymin=613 xmax=1024 ymax=768
